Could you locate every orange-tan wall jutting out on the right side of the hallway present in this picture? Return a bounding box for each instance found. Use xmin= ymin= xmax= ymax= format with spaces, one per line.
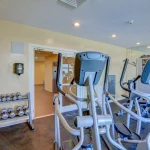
xmin=45 ymin=54 xmax=58 ymax=92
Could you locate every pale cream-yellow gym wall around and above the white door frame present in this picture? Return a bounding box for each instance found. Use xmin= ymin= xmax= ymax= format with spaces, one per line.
xmin=0 ymin=20 xmax=145 ymax=97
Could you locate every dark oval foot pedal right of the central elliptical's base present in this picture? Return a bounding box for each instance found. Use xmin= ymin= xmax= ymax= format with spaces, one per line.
xmin=115 ymin=123 xmax=132 ymax=138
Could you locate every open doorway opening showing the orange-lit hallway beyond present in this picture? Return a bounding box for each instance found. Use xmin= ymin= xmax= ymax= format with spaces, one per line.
xmin=34 ymin=49 xmax=58 ymax=118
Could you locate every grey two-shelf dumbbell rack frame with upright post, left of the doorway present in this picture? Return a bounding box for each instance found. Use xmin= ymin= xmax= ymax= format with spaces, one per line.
xmin=0 ymin=93 xmax=34 ymax=130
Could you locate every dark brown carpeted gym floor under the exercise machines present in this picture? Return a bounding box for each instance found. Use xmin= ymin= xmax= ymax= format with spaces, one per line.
xmin=0 ymin=101 xmax=150 ymax=150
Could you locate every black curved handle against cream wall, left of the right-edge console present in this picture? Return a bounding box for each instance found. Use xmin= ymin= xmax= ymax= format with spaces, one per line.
xmin=120 ymin=58 xmax=131 ymax=92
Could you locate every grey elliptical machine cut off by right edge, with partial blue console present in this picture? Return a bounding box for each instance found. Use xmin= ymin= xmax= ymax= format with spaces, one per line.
xmin=106 ymin=60 xmax=150 ymax=150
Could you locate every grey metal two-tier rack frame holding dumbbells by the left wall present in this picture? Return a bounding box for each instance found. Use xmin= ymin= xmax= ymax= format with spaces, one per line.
xmin=0 ymin=93 xmax=34 ymax=130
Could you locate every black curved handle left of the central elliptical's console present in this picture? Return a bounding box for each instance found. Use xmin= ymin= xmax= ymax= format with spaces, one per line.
xmin=56 ymin=53 xmax=66 ymax=96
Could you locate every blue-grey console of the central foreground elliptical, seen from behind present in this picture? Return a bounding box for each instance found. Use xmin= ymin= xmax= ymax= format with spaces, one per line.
xmin=74 ymin=52 xmax=108 ymax=86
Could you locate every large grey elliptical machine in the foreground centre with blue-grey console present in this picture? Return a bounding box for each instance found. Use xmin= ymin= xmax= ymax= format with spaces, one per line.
xmin=54 ymin=52 xmax=125 ymax=150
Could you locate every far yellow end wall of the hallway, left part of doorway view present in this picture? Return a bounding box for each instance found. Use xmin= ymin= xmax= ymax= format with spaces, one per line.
xmin=34 ymin=61 xmax=45 ymax=85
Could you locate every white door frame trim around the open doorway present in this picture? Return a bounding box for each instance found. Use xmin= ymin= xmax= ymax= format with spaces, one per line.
xmin=28 ymin=44 xmax=81 ymax=119
